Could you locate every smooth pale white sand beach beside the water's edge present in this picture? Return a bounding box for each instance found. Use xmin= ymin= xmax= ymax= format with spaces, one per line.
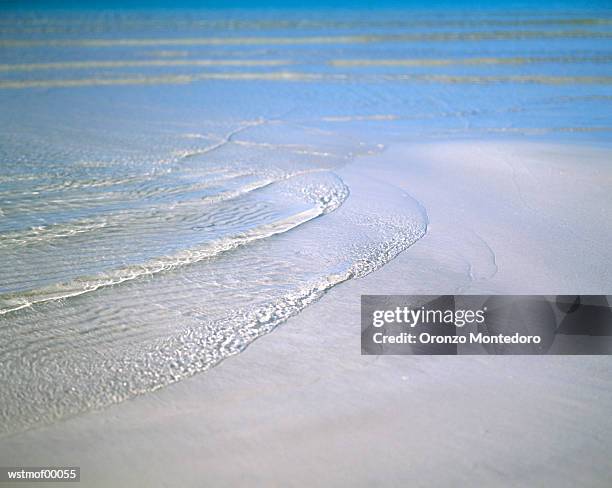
xmin=0 ymin=140 xmax=612 ymax=487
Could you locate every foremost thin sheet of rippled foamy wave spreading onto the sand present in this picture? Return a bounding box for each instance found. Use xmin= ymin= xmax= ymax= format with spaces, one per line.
xmin=0 ymin=167 xmax=427 ymax=434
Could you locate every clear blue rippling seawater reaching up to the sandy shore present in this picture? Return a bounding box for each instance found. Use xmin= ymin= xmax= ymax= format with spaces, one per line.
xmin=0 ymin=10 xmax=612 ymax=434
